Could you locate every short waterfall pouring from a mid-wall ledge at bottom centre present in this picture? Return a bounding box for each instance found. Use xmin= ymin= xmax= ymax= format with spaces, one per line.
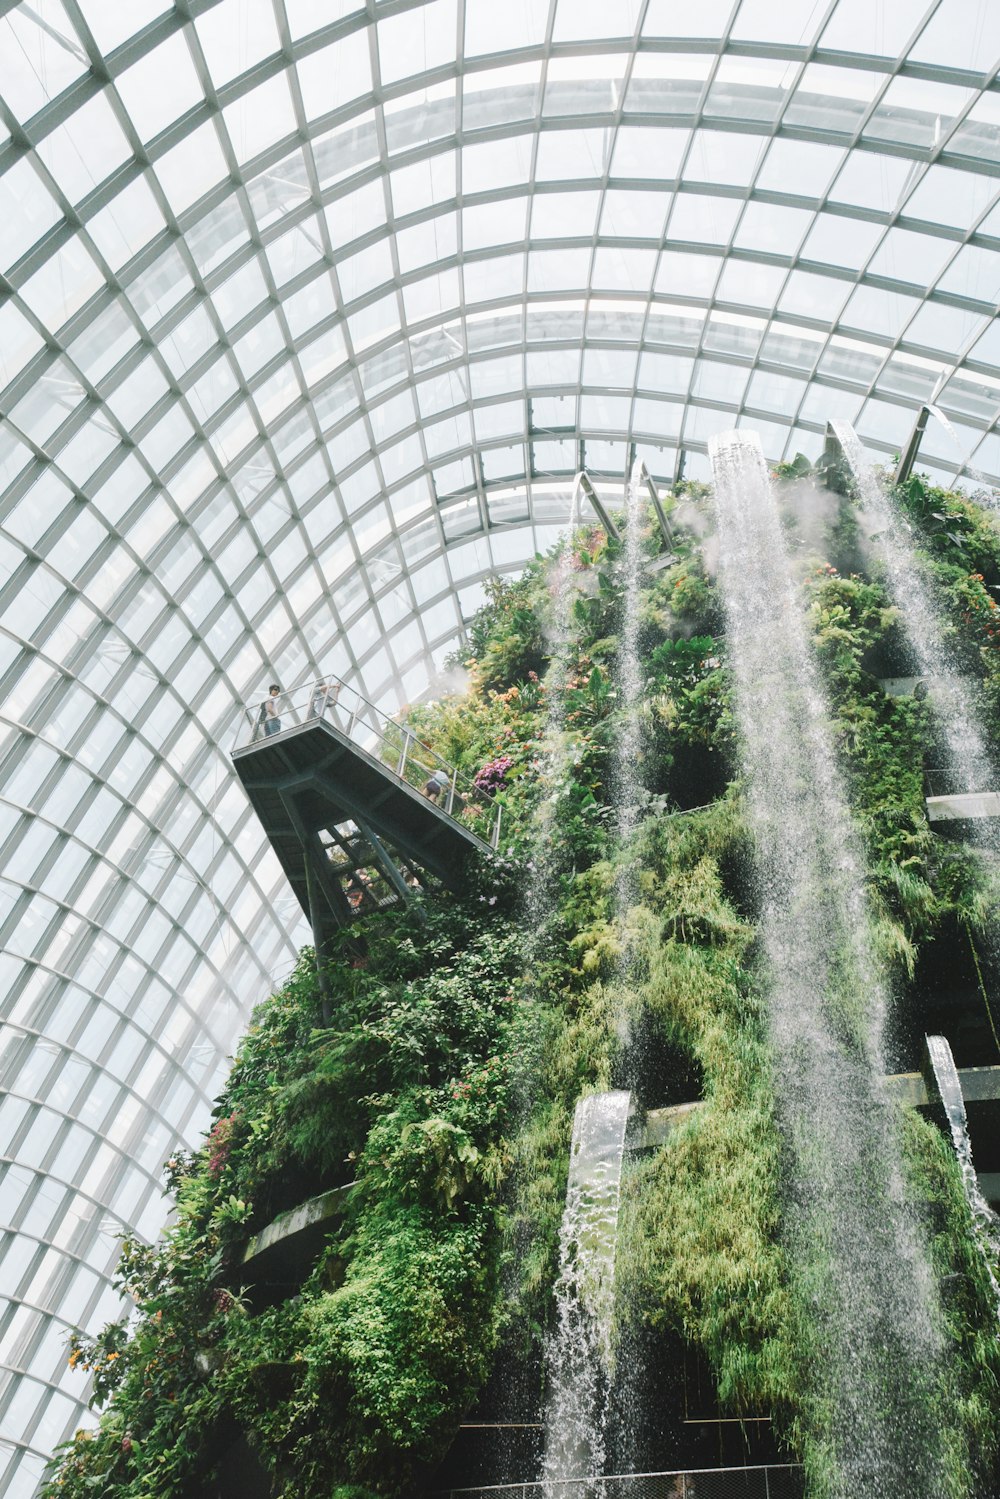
xmin=543 ymin=1091 xmax=631 ymax=1499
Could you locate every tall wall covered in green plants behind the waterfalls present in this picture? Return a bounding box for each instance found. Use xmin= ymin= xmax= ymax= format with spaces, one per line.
xmin=45 ymin=468 xmax=1000 ymax=1499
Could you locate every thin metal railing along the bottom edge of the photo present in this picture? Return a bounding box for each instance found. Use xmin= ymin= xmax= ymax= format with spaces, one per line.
xmin=439 ymin=1463 xmax=804 ymax=1499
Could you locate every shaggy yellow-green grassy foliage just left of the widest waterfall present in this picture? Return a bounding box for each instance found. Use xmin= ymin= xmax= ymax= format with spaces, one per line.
xmin=619 ymin=799 xmax=793 ymax=1415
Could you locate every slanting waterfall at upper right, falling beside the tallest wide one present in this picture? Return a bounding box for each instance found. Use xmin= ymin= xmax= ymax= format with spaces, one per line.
xmin=831 ymin=421 xmax=1000 ymax=815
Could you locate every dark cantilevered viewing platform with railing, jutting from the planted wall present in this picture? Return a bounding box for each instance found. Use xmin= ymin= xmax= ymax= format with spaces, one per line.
xmin=232 ymin=678 xmax=499 ymax=950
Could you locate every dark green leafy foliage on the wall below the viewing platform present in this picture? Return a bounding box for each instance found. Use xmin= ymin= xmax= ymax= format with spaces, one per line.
xmin=41 ymin=899 xmax=520 ymax=1499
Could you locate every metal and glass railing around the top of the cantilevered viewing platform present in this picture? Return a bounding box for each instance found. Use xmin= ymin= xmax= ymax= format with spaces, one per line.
xmin=232 ymin=676 xmax=502 ymax=848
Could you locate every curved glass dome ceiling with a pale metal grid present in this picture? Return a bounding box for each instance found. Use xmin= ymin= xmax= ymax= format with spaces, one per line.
xmin=0 ymin=0 xmax=1000 ymax=1496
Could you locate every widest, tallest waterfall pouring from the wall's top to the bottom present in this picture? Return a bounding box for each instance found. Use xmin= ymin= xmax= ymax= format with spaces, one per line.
xmin=709 ymin=433 xmax=945 ymax=1499
